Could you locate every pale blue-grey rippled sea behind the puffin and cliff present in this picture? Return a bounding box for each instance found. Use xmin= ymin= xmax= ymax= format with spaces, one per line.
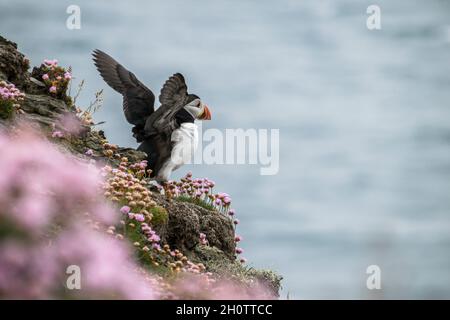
xmin=0 ymin=0 xmax=450 ymax=299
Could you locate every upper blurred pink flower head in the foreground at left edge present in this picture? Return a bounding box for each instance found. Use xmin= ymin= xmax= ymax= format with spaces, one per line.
xmin=0 ymin=126 xmax=114 ymax=229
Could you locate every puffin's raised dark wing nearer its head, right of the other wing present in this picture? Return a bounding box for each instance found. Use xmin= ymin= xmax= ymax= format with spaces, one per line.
xmin=145 ymin=73 xmax=188 ymax=135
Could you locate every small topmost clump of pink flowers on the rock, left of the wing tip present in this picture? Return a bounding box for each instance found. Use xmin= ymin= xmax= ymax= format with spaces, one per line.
xmin=41 ymin=59 xmax=72 ymax=94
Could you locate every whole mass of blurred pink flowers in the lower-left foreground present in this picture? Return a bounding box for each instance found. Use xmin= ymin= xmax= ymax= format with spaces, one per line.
xmin=0 ymin=124 xmax=156 ymax=299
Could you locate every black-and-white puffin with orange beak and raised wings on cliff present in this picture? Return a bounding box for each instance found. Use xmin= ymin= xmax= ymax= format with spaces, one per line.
xmin=92 ymin=49 xmax=211 ymax=183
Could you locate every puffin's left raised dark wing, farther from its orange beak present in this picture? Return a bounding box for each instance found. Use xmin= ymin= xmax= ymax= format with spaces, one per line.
xmin=92 ymin=49 xmax=155 ymax=126
